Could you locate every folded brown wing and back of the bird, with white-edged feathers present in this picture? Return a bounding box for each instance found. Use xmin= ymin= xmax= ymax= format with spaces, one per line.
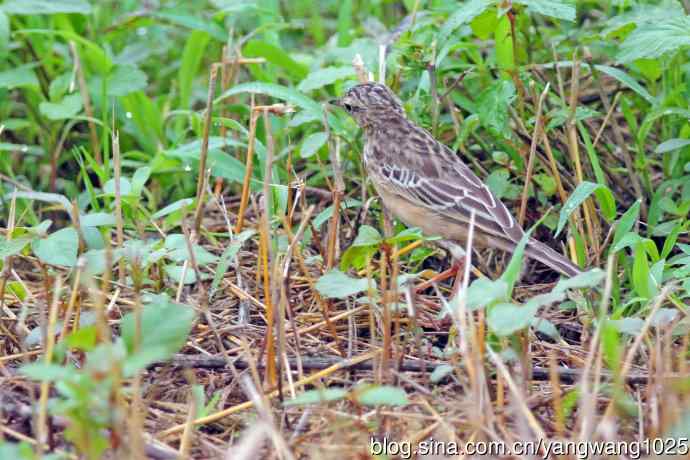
xmin=368 ymin=122 xmax=523 ymax=244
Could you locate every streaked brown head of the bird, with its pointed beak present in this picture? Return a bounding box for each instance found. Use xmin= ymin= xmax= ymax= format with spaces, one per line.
xmin=331 ymin=82 xmax=405 ymax=129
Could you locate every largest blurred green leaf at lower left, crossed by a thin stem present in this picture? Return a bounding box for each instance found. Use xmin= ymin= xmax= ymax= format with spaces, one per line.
xmin=121 ymin=296 xmax=196 ymax=362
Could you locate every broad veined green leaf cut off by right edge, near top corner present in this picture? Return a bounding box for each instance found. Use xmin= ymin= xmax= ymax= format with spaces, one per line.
xmin=616 ymin=15 xmax=690 ymax=63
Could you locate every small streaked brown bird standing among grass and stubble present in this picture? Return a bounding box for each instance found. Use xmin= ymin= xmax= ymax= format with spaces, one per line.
xmin=329 ymin=82 xmax=581 ymax=277
